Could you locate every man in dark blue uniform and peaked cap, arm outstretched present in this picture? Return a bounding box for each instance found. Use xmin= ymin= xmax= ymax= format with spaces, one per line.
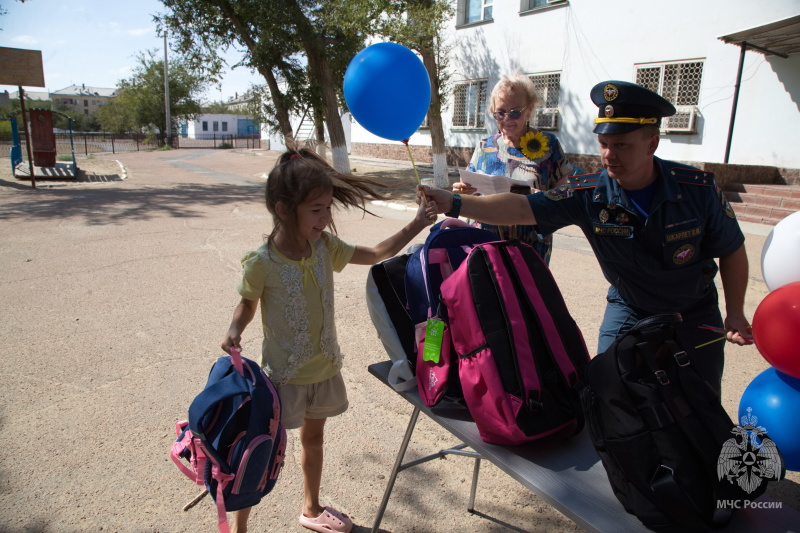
xmin=423 ymin=81 xmax=751 ymax=392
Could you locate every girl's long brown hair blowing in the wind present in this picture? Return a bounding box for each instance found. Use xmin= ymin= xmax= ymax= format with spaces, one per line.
xmin=266 ymin=143 xmax=387 ymax=247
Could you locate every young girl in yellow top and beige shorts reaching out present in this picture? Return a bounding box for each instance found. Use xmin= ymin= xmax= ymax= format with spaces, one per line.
xmin=222 ymin=148 xmax=436 ymax=533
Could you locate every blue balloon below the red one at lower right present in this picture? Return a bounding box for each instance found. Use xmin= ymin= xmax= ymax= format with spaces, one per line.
xmin=739 ymin=367 xmax=800 ymax=471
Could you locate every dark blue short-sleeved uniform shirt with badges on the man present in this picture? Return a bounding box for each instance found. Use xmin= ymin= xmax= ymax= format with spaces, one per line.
xmin=528 ymin=157 xmax=744 ymax=316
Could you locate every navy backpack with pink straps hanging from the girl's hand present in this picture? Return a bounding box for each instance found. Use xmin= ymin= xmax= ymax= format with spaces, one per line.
xmin=170 ymin=349 xmax=286 ymax=533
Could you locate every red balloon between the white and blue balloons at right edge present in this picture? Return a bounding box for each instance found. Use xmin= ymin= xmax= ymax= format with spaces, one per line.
xmin=753 ymin=281 xmax=800 ymax=378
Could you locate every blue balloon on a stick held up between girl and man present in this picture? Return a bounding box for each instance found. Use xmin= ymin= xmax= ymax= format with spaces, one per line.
xmin=344 ymin=43 xmax=431 ymax=141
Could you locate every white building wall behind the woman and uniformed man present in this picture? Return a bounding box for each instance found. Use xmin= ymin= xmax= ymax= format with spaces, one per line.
xmin=352 ymin=0 xmax=800 ymax=168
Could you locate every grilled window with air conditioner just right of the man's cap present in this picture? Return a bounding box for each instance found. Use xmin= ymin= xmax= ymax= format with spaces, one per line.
xmin=635 ymin=61 xmax=703 ymax=133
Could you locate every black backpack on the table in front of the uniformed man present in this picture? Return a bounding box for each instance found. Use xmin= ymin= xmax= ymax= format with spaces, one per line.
xmin=581 ymin=314 xmax=785 ymax=531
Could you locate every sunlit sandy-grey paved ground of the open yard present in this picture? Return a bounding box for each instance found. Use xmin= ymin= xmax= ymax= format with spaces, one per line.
xmin=0 ymin=150 xmax=800 ymax=532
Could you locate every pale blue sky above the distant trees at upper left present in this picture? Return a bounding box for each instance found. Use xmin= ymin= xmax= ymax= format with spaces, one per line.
xmin=0 ymin=0 xmax=263 ymax=102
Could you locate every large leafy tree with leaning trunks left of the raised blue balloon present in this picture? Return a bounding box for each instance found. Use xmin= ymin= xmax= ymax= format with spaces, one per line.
xmin=156 ymin=0 xmax=363 ymax=171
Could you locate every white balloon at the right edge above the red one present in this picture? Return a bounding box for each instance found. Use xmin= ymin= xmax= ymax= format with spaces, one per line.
xmin=761 ymin=211 xmax=800 ymax=291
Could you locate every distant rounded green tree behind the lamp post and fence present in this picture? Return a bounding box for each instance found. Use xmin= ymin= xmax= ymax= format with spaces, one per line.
xmin=98 ymin=50 xmax=209 ymax=135
